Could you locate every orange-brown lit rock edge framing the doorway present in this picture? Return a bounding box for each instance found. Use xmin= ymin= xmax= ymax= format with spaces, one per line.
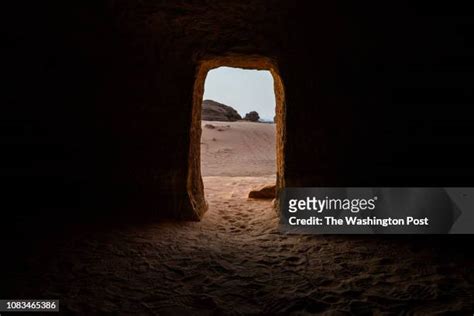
xmin=187 ymin=56 xmax=286 ymax=220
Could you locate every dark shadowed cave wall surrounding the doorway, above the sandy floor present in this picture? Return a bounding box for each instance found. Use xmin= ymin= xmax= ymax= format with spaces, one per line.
xmin=1 ymin=0 xmax=474 ymax=219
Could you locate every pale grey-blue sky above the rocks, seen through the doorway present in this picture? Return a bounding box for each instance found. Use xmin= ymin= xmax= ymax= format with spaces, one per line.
xmin=203 ymin=67 xmax=275 ymax=121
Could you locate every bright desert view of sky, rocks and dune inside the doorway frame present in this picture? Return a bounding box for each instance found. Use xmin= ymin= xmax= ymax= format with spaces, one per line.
xmin=201 ymin=67 xmax=276 ymax=177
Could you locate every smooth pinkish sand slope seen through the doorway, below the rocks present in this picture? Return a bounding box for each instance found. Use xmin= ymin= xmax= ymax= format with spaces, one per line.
xmin=201 ymin=121 xmax=276 ymax=176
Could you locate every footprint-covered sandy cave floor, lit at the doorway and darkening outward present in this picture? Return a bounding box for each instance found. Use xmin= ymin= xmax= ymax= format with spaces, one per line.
xmin=4 ymin=177 xmax=474 ymax=315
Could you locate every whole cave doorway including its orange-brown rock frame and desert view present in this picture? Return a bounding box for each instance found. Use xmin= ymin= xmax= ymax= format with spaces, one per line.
xmin=188 ymin=57 xmax=285 ymax=219
